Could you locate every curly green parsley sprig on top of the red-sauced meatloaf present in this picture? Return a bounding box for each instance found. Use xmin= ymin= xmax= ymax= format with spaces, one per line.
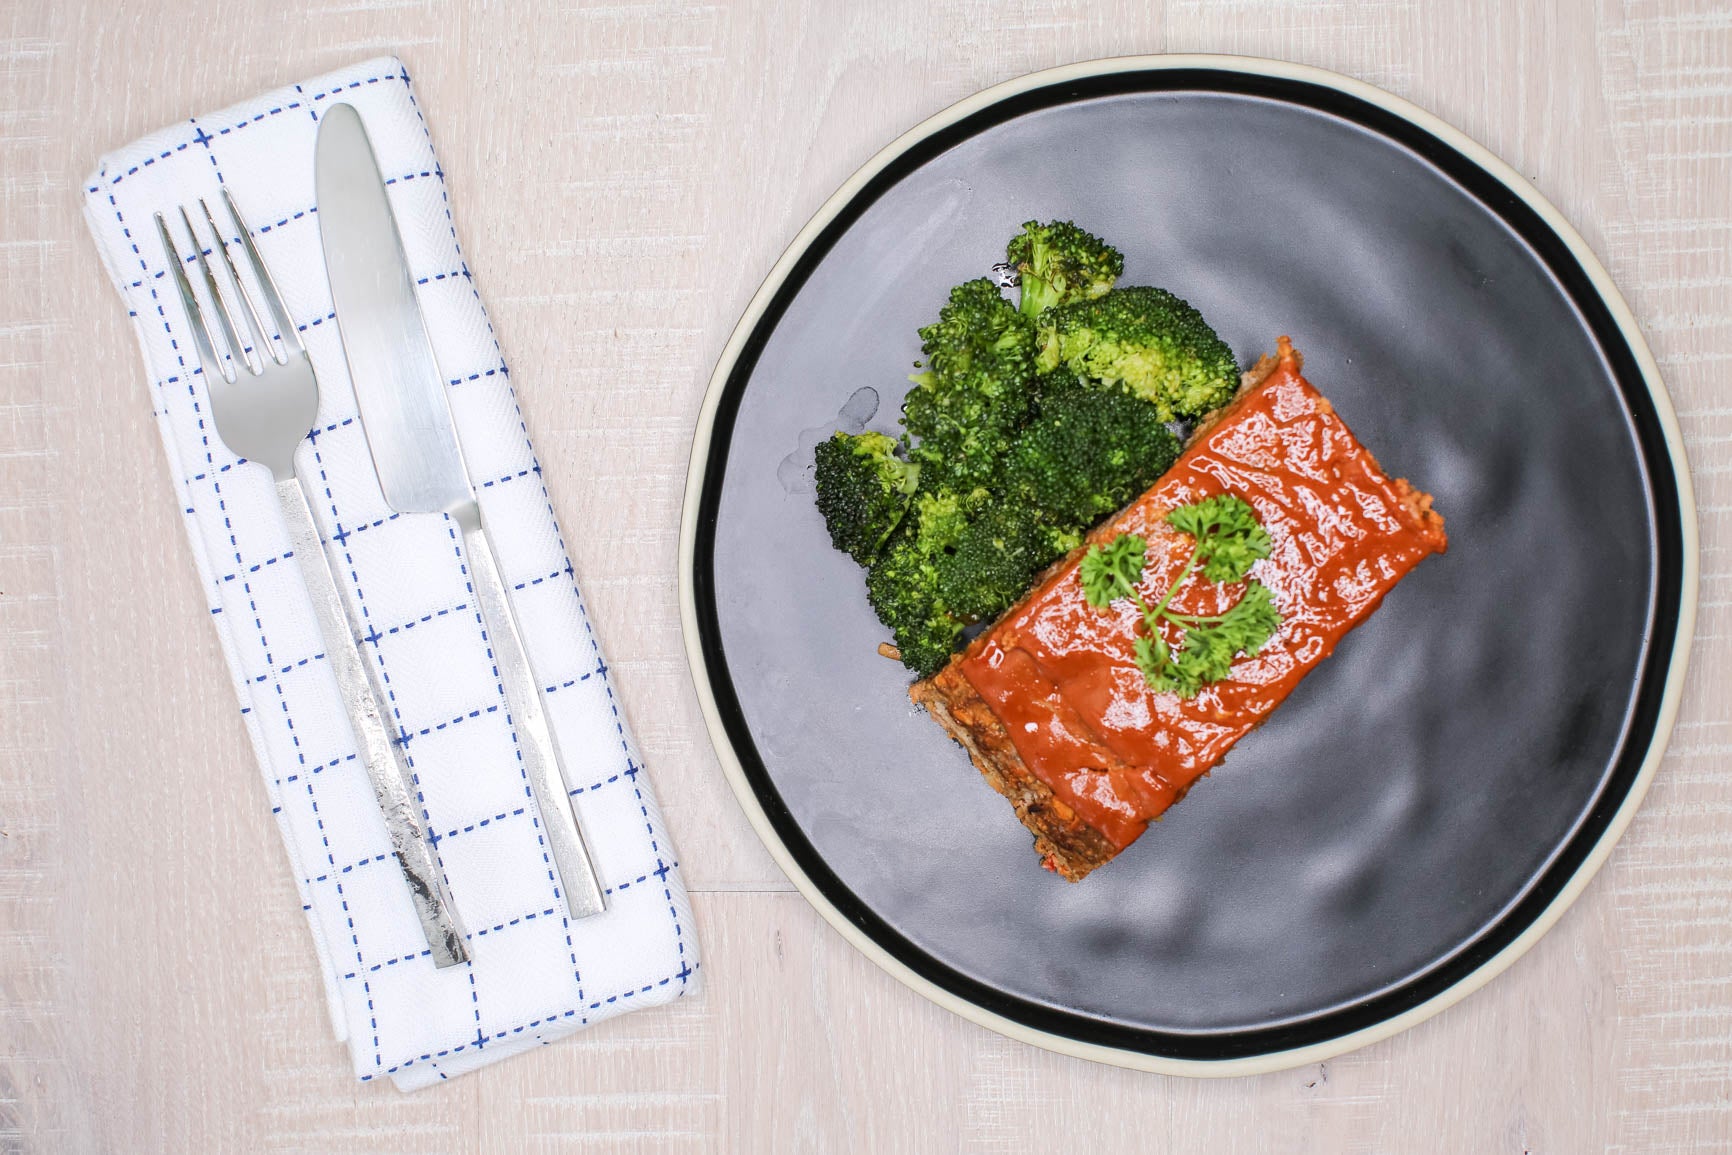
xmin=1077 ymin=494 xmax=1282 ymax=698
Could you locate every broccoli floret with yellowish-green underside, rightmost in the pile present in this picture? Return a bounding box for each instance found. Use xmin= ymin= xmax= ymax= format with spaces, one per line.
xmin=1039 ymin=286 xmax=1238 ymax=421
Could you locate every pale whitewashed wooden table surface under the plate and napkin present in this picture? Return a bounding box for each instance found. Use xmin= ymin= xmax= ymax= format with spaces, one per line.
xmin=0 ymin=0 xmax=1732 ymax=1155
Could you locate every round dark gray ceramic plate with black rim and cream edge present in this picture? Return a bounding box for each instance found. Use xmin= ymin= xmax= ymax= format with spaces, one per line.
xmin=682 ymin=57 xmax=1696 ymax=1074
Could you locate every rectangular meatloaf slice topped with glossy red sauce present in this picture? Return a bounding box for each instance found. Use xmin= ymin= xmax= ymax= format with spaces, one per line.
xmin=909 ymin=338 xmax=1448 ymax=881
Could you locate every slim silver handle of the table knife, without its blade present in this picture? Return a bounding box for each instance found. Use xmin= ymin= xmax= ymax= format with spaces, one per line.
xmin=452 ymin=502 xmax=606 ymax=918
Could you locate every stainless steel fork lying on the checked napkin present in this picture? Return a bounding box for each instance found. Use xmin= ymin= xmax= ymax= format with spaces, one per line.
xmin=156 ymin=189 xmax=469 ymax=968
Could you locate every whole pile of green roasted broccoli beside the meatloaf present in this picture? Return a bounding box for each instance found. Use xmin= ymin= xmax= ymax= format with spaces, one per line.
xmin=816 ymin=222 xmax=1238 ymax=677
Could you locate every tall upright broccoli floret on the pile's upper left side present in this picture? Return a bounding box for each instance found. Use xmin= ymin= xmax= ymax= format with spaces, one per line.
xmin=902 ymin=277 xmax=1034 ymax=494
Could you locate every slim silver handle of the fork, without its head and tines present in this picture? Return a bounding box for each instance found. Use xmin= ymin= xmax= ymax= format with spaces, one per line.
xmin=277 ymin=476 xmax=469 ymax=968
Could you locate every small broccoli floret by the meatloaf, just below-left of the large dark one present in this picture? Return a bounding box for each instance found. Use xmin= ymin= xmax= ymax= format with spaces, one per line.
xmin=939 ymin=502 xmax=1083 ymax=622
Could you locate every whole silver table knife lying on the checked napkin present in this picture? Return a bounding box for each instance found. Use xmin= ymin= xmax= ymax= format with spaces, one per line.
xmin=313 ymin=104 xmax=606 ymax=918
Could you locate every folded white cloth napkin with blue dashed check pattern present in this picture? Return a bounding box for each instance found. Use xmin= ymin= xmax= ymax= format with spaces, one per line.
xmin=85 ymin=59 xmax=698 ymax=1089
